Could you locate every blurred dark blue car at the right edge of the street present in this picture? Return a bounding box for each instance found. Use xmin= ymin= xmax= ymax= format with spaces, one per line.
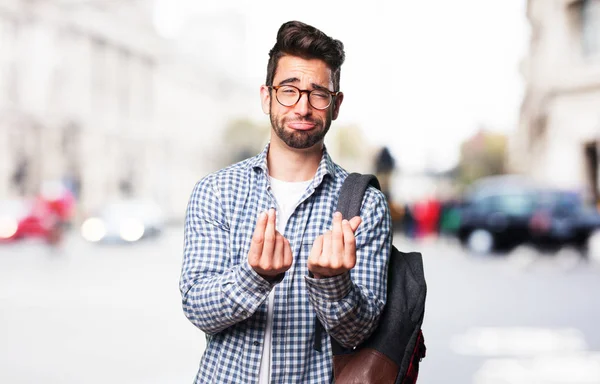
xmin=457 ymin=175 xmax=600 ymax=253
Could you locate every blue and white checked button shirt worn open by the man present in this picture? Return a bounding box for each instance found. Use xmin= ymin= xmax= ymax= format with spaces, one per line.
xmin=180 ymin=145 xmax=392 ymax=384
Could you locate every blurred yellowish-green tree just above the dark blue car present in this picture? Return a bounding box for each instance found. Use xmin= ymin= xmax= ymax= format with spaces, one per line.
xmin=457 ymin=128 xmax=507 ymax=185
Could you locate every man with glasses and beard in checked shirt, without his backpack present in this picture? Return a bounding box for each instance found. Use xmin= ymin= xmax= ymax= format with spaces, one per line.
xmin=180 ymin=21 xmax=392 ymax=384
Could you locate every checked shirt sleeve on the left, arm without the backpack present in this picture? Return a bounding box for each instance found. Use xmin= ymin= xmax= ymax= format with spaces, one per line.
xmin=179 ymin=176 xmax=277 ymax=334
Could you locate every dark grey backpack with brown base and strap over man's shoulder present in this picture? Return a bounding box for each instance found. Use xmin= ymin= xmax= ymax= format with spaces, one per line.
xmin=315 ymin=173 xmax=427 ymax=384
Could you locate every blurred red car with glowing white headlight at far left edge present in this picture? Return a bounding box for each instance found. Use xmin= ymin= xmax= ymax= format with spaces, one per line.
xmin=0 ymin=199 xmax=56 ymax=243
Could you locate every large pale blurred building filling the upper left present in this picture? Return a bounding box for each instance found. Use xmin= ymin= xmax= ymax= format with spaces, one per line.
xmin=0 ymin=0 xmax=250 ymax=218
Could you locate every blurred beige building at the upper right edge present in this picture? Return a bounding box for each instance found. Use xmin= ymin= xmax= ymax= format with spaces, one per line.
xmin=510 ymin=0 xmax=600 ymax=201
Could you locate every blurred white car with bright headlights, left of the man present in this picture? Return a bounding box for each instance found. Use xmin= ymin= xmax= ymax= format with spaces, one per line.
xmin=81 ymin=199 xmax=165 ymax=243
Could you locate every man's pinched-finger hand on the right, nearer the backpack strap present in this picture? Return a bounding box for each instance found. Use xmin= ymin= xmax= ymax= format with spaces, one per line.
xmin=307 ymin=212 xmax=361 ymax=278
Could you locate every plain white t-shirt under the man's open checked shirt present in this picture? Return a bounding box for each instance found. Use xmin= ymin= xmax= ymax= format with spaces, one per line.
xmin=258 ymin=177 xmax=312 ymax=384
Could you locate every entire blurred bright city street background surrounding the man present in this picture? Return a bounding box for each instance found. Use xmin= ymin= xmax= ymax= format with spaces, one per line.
xmin=0 ymin=0 xmax=600 ymax=384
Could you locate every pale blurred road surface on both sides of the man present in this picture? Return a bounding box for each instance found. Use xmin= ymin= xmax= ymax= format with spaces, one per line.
xmin=0 ymin=228 xmax=600 ymax=384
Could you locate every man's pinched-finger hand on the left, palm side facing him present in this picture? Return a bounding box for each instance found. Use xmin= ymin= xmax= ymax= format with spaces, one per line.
xmin=248 ymin=208 xmax=292 ymax=280
